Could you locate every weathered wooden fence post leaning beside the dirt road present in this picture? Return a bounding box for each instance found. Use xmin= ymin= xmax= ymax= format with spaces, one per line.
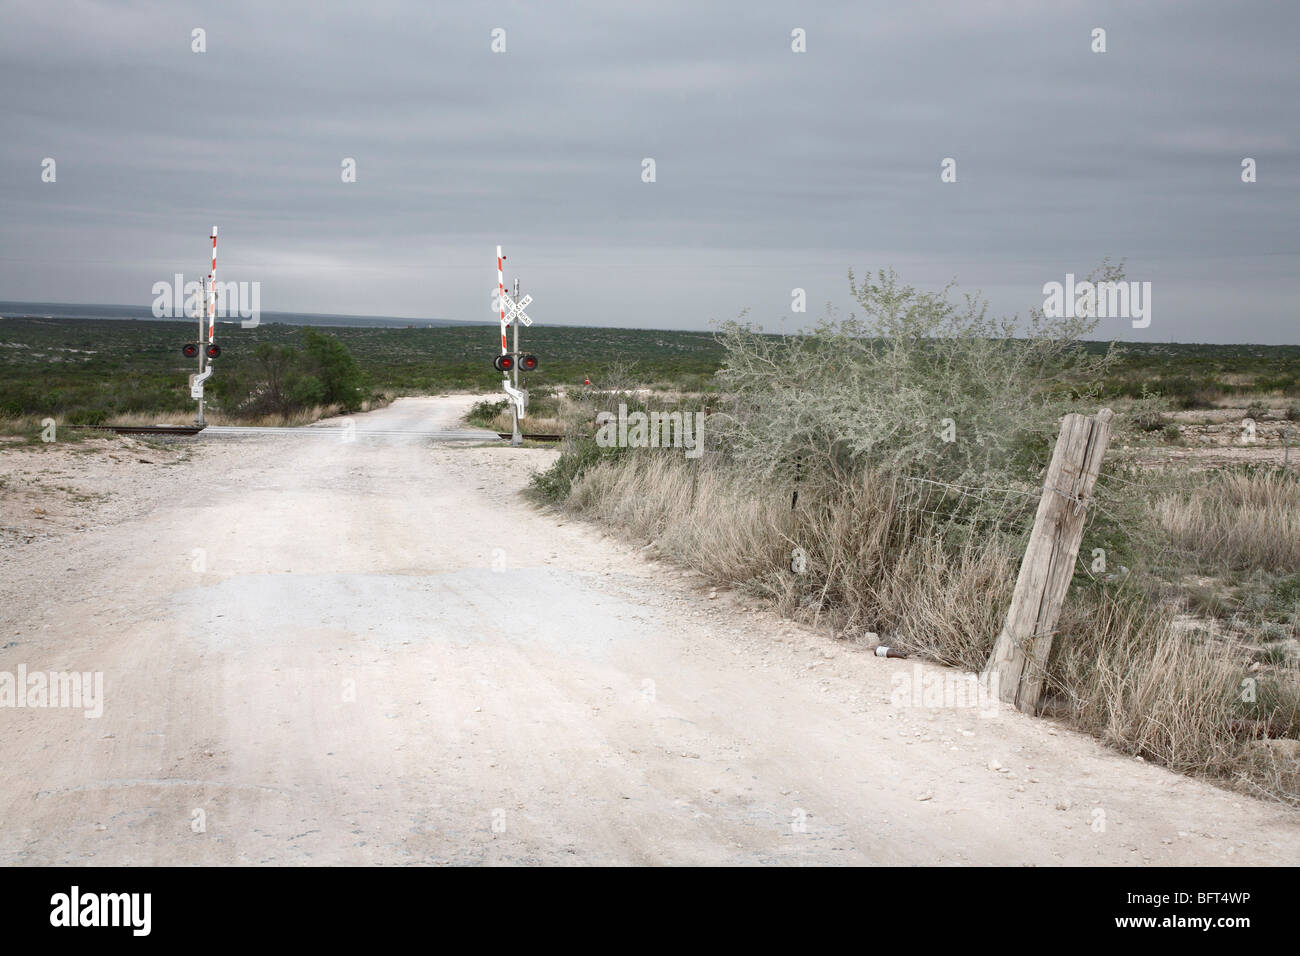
xmin=984 ymin=408 xmax=1114 ymax=714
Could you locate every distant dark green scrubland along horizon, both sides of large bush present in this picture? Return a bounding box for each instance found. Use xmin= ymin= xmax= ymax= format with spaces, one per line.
xmin=0 ymin=317 xmax=1300 ymax=423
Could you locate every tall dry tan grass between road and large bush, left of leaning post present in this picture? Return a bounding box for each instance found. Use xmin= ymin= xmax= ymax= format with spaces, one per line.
xmin=566 ymin=444 xmax=1019 ymax=667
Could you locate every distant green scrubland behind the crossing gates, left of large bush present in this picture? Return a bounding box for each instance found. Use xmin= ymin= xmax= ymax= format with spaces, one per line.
xmin=0 ymin=317 xmax=722 ymax=424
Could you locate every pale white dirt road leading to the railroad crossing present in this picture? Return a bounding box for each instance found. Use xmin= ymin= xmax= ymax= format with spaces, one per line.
xmin=0 ymin=397 xmax=1300 ymax=865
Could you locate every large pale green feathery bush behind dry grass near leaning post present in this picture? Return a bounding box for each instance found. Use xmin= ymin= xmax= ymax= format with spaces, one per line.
xmin=718 ymin=265 xmax=1122 ymax=496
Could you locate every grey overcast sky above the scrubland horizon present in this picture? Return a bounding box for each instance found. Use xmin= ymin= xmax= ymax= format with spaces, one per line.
xmin=0 ymin=0 xmax=1300 ymax=343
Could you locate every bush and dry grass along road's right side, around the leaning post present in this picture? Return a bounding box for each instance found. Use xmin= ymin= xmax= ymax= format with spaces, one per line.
xmin=534 ymin=267 xmax=1300 ymax=805
